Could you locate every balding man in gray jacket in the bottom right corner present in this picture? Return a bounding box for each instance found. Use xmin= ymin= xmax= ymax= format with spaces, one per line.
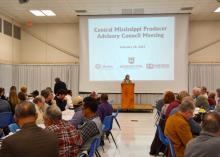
xmin=185 ymin=112 xmax=220 ymax=157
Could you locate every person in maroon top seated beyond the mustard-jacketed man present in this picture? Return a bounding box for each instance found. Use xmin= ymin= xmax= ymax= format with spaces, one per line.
xmin=166 ymin=91 xmax=189 ymax=118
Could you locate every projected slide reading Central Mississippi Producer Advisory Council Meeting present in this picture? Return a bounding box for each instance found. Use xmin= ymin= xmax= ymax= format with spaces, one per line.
xmin=88 ymin=16 xmax=175 ymax=81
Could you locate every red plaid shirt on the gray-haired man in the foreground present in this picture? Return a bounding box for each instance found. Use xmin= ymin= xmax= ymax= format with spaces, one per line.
xmin=46 ymin=120 xmax=83 ymax=157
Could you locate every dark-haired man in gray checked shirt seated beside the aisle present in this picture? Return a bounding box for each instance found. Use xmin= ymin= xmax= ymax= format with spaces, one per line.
xmin=79 ymin=97 xmax=102 ymax=151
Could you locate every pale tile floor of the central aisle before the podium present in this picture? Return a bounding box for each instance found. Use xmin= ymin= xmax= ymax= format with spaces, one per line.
xmin=99 ymin=113 xmax=156 ymax=157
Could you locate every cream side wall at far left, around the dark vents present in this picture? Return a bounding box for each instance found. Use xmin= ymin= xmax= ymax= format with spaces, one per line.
xmin=0 ymin=14 xmax=21 ymax=64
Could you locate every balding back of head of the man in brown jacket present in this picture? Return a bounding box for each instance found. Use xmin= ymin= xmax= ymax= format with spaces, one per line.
xmin=15 ymin=101 xmax=36 ymax=119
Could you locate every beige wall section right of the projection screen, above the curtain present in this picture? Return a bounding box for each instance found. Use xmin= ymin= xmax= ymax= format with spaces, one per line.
xmin=189 ymin=21 xmax=220 ymax=63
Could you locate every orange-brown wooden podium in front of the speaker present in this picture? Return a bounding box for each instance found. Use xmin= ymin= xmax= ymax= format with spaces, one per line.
xmin=121 ymin=83 xmax=134 ymax=109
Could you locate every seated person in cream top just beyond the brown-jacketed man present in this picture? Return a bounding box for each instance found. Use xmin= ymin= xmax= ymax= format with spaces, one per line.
xmin=33 ymin=96 xmax=48 ymax=124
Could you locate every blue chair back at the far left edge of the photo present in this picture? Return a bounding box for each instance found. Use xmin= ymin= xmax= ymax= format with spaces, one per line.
xmin=0 ymin=112 xmax=13 ymax=128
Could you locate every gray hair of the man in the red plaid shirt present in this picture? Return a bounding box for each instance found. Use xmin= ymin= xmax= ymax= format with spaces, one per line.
xmin=45 ymin=105 xmax=62 ymax=121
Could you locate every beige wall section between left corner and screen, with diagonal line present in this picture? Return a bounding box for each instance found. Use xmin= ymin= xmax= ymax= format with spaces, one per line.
xmin=20 ymin=24 xmax=79 ymax=64
